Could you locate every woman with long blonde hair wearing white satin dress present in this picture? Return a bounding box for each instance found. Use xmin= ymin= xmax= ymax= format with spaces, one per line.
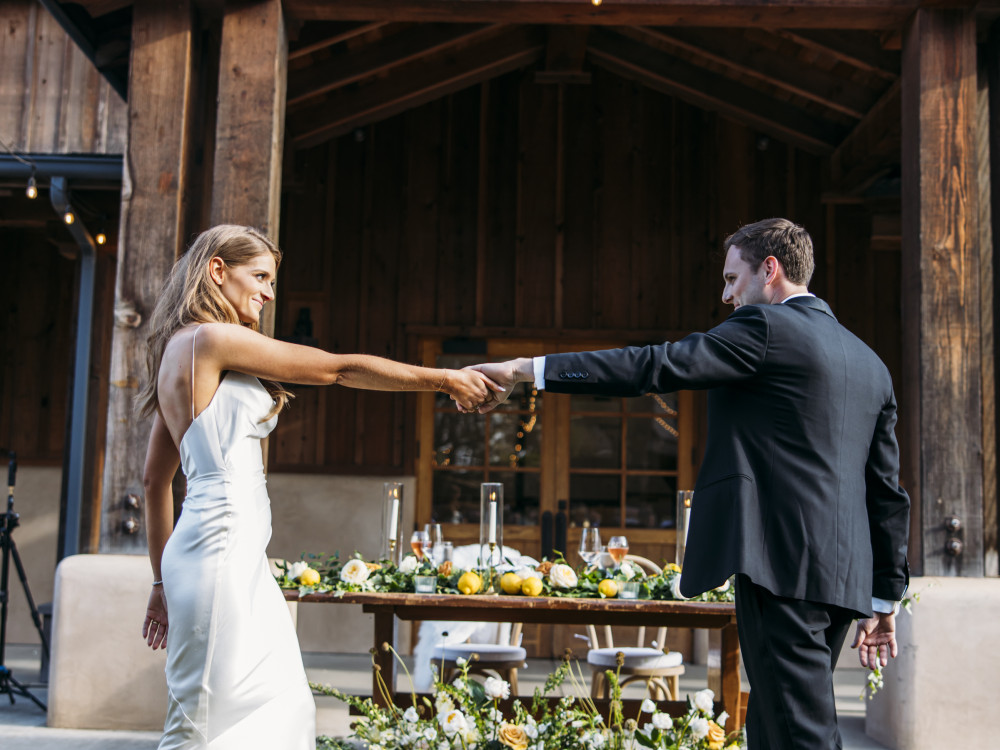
xmin=139 ymin=225 xmax=499 ymax=750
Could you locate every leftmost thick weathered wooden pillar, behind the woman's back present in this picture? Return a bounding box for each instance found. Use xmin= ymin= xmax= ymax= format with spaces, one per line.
xmin=101 ymin=0 xmax=195 ymax=552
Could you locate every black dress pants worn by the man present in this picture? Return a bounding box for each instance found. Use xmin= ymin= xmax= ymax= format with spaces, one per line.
xmin=736 ymin=575 xmax=855 ymax=750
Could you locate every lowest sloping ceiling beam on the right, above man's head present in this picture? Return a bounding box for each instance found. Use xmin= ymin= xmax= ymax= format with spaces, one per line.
xmin=587 ymin=29 xmax=839 ymax=153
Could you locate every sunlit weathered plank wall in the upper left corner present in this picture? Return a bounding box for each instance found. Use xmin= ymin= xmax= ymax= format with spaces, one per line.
xmin=0 ymin=0 xmax=126 ymax=154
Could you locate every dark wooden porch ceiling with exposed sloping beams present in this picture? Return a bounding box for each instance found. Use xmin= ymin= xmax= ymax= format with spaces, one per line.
xmin=47 ymin=0 xmax=995 ymax=196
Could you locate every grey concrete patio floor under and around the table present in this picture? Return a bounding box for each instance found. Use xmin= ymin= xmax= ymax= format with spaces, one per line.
xmin=0 ymin=645 xmax=885 ymax=750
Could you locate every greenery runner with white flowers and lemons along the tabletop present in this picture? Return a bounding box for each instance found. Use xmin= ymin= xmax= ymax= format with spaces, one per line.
xmin=276 ymin=553 xmax=734 ymax=602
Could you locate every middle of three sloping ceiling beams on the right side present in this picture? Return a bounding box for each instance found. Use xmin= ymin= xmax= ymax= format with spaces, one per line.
xmin=637 ymin=28 xmax=878 ymax=120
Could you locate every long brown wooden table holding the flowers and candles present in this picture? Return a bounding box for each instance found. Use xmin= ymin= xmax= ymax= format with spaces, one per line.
xmin=285 ymin=590 xmax=742 ymax=732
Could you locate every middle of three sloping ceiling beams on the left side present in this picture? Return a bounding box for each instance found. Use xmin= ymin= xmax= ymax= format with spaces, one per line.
xmin=288 ymin=24 xmax=498 ymax=107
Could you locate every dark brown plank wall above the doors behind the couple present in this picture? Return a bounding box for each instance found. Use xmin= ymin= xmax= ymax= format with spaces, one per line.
xmin=271 ymin=69 xmax=901 ymax=474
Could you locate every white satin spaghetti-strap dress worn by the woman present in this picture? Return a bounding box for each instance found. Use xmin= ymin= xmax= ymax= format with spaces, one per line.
xmin=159 ymin=356 xmax=316 ymax=750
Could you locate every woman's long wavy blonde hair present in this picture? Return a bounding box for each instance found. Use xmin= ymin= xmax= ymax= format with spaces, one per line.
xmin=136 ymin=224 xmax=292 ymax=420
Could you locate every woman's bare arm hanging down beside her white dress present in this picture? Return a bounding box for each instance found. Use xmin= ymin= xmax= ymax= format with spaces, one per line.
xmin=142 ymin=412 xmax=181 ymax=650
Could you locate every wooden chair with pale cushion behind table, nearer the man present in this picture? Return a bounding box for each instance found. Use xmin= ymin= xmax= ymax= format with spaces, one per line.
xmin=587 ymin=555 xmax=684 ymax=700
